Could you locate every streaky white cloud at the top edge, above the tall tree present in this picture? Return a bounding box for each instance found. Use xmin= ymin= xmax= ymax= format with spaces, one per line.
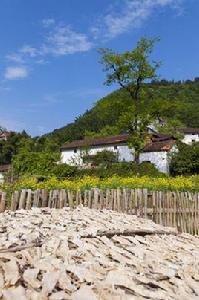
xmin=91 ymin=0 xmax=183 ymax=39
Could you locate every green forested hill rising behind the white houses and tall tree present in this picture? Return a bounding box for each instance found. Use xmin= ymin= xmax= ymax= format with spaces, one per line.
xmin=43 ymin=78 xmax=199 ymax=144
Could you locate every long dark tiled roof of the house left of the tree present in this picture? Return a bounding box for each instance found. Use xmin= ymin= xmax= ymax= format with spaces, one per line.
xmin=61 ymin=133 xmax=129 ymax=150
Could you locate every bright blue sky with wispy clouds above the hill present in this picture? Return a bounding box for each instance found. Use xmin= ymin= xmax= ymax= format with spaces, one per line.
xmin=0 ymin=0 xmax=199 ymax=136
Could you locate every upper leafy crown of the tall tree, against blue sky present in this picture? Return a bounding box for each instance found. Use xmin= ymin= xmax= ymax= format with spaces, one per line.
xmin=99 ymin=38 xmax=159 ymax=86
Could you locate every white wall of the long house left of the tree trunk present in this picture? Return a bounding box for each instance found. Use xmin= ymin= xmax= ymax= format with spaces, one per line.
xmin=61 ymin=145 xmax=134 ymax=166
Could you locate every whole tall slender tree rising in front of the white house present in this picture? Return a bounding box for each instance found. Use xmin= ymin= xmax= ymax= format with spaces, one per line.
xmin=99 ymin=38 xmax=160 ymax=163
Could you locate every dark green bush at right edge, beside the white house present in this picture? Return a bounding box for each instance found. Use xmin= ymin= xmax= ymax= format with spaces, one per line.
xmin=170 ymin=143 xmax=199 ymax=175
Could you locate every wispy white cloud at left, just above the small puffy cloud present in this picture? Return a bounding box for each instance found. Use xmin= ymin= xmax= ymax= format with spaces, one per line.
xmin=6 ymin=19 xmax=92 ymax=68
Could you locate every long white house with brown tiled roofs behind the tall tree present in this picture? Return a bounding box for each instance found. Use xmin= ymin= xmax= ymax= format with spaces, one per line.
xmin=61 ymin=133 xmax=175 ymax=173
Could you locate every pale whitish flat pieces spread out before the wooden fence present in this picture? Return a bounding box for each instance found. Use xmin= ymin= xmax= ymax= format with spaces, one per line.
xmin=0 ymin=207 xmax=199 ymax=300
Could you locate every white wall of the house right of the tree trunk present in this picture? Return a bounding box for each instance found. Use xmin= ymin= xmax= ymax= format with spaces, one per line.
xmin=140 ymin=151 xmax=169 ymax=173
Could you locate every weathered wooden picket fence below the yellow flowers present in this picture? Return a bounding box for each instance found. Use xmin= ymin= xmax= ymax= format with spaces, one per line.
xmin=0 ymin=188 xmax=199 ymax=235
